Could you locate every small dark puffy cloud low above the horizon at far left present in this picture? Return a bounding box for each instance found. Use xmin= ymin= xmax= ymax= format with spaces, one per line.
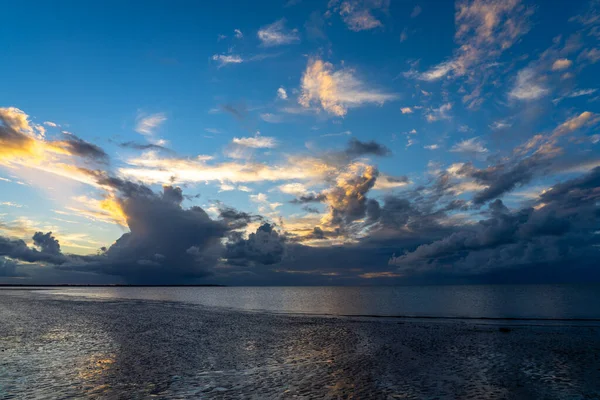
xmin=0 ymin=232 xmax=68 ymax=264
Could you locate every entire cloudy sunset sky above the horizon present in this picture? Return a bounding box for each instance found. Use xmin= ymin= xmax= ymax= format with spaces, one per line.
xmin=0 ymin=0 xmax=600 ymax=285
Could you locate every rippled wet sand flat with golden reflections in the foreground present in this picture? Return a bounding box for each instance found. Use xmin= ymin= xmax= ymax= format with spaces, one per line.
xmin=0 ymin=290 xmax=600 ymax=399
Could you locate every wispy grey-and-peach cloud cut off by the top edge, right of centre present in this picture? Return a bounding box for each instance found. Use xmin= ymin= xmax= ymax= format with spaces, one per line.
xmin=329 ymin=0 xmax=390 ymax=32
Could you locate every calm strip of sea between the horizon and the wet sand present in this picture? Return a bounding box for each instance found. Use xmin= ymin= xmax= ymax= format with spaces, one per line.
xmin=36 ymin=285 xmax=600 ymax=319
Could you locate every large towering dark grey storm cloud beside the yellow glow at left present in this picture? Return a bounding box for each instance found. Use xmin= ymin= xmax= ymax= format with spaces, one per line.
xmin=63 ymin=183 xmax=229 ymax=283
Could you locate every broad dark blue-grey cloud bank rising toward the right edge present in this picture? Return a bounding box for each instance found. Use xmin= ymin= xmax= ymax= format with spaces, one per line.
xmin=390 ymin=168 xmax=600 ymax=273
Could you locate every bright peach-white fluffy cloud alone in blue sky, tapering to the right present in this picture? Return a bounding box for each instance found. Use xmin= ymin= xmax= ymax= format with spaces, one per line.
xmin=298 ymin=59 xmax=397 ymax=117
